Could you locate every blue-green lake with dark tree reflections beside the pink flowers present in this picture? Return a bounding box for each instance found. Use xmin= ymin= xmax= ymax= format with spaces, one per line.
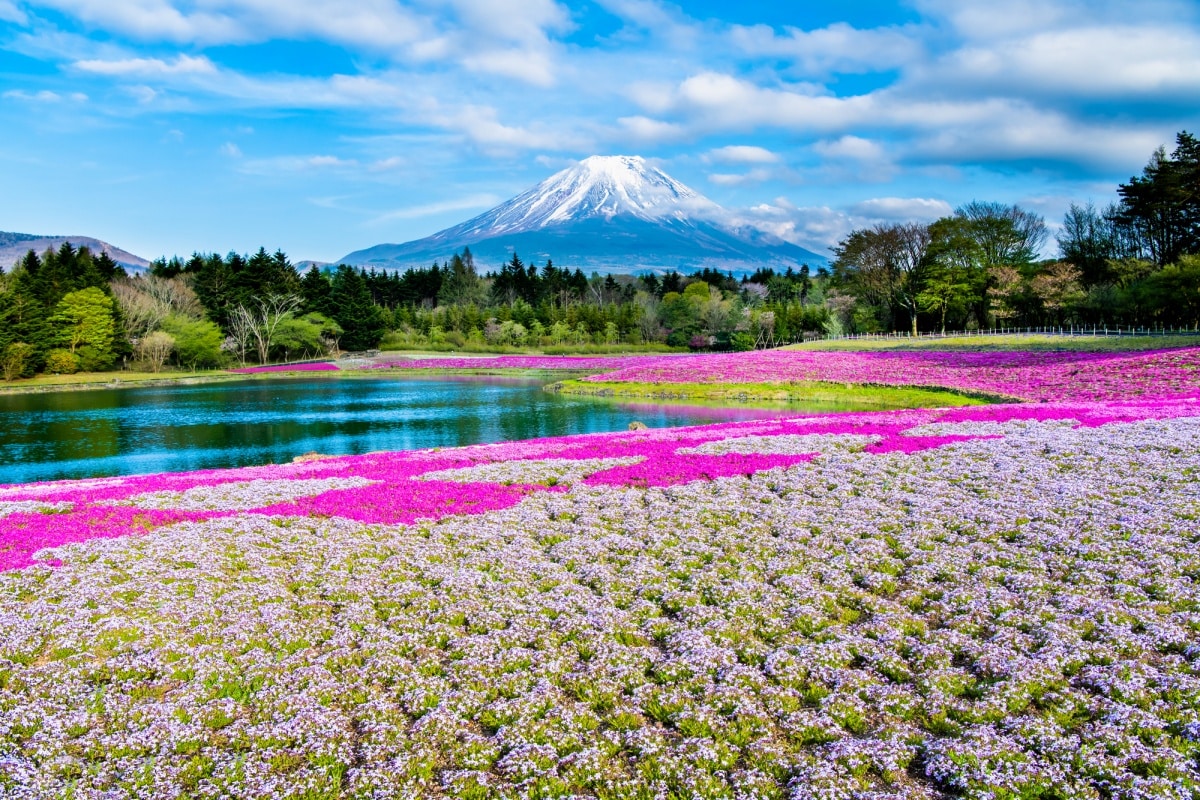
xmin=0 ymin=377 xmax=801 ymax=483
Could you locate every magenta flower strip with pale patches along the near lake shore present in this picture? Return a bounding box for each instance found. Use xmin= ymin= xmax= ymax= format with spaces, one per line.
xmin=0 ymin=397 xmax=1200 ymax=571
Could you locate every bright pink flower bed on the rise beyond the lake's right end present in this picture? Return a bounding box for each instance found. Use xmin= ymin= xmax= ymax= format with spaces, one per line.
xmin=583 ymin=348 xmax=1200 ymax=402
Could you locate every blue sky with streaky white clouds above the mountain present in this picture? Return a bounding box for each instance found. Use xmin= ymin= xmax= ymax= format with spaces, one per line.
xmin=0 ymin=0 xmax=1200 ymax=260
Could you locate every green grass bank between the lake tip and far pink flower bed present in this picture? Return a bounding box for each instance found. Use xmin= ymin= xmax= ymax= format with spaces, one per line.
xmin=546 ymin=380 xmax=1000 ymax=411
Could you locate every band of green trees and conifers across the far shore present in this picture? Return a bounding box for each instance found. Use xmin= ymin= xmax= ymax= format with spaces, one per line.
xmin=0 ymin=132 xmax=1200 ymax=380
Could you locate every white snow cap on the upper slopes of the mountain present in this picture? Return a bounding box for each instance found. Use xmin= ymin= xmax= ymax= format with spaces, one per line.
xmin=448 ymin=156 xmax=720 ymax=234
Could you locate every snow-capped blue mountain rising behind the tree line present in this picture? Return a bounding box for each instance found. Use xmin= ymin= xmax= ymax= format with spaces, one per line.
xmin=338 ymin=156 xmax=829 ymax=273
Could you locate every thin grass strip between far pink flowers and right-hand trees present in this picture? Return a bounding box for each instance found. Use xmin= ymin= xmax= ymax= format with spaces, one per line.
xmin=781 ymin=333 xmax=1200 ymax=353
